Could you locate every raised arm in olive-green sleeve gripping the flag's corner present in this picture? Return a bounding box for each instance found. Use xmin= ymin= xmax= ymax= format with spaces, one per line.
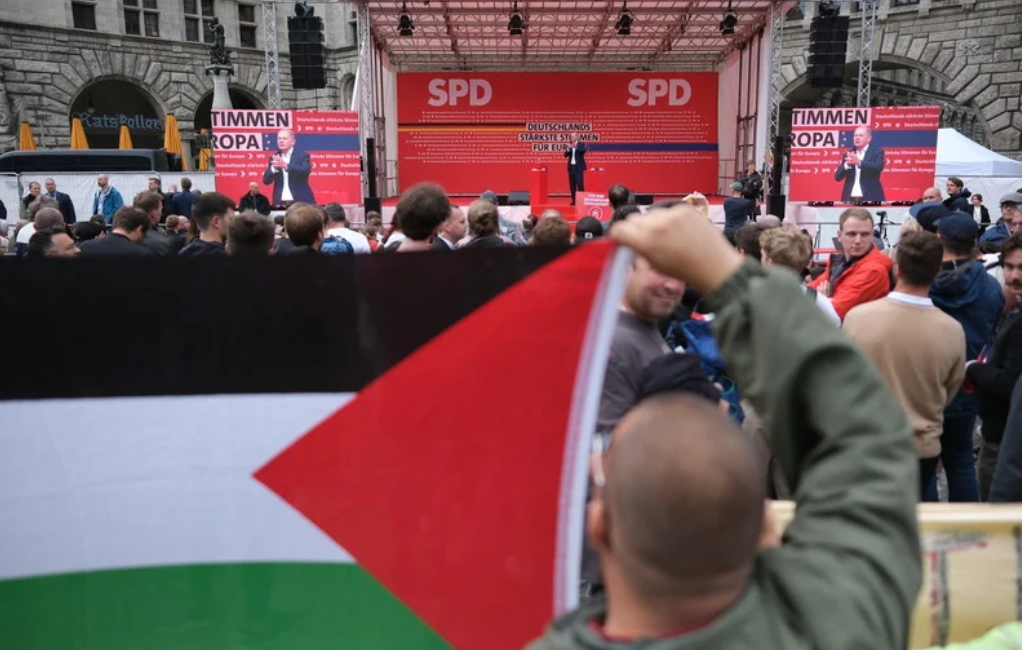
xmin=611 ymin=208 xmax=922 ymax=648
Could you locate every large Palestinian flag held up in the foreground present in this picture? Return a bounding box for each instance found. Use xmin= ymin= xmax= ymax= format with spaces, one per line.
xmin=0 ymin=243 xmax=625 ymax=650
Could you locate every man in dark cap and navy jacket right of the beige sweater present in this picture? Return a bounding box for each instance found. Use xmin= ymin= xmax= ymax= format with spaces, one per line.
xmin=924 ymin=212 xmax=1005 ymax=503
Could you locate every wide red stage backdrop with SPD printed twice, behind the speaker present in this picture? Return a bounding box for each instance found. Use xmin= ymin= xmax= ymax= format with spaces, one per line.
xmin=398 ymin=73 xmax=717 ymax=194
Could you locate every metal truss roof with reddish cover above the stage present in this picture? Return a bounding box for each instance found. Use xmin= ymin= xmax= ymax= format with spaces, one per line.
xmin=369 ymin=0 xmax=771 ymax=71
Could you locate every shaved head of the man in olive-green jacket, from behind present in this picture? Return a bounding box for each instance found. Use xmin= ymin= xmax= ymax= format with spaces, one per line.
xmin=591 ymin=393 xmax=767 ymax=599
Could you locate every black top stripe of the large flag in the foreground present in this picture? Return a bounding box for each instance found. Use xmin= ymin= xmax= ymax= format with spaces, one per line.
xmin=0 ymin=247 xmax=568 ymax=400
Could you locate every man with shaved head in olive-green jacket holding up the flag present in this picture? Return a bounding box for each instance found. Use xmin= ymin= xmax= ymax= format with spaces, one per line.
xmin=530 ymin=206 xmax=922 ymax=650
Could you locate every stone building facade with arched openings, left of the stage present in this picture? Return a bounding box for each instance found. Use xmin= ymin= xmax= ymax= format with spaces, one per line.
xmin=0 ymin=0 xmax=358 ymax=160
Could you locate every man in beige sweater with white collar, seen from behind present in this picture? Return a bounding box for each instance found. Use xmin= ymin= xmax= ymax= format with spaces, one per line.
xmin=844 ymin=232 xmax=965 ymax=497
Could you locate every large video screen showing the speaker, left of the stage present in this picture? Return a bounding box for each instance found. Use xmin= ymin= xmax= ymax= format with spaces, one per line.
xmin=213 ymin=110 xmax=362 ymax=205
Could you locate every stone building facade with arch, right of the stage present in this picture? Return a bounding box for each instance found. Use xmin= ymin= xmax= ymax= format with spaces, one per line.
xmin=781 ymin=0 xmax=1022 ymax=157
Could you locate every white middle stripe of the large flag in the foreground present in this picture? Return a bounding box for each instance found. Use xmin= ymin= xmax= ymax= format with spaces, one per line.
xmin=0 ymin=393 xmax=354 ymax=579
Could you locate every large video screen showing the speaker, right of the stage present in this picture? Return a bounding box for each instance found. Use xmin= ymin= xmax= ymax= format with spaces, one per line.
xmin=788 ymin=106 xmax=940 ymax=202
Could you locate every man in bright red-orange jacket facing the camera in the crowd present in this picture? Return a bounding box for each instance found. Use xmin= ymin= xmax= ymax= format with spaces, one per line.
xmin=809 ymin=207 xmax=893 ymax=320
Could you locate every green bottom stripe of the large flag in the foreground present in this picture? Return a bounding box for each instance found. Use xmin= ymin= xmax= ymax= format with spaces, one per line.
xmin=0 ymin=563 xmax=451 ymax=650
